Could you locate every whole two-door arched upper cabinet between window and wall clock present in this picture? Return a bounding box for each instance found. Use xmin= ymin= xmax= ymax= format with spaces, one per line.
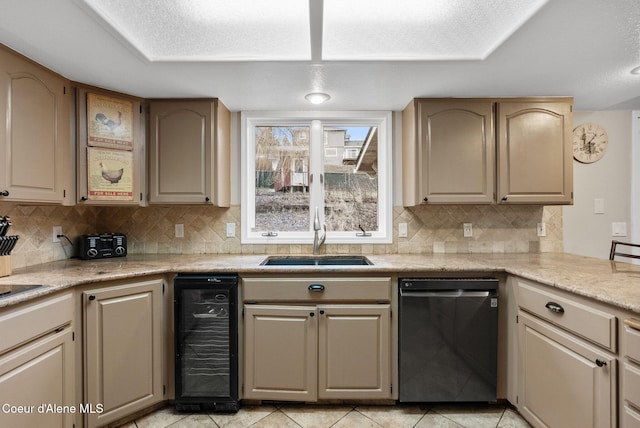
xmin=402 ymin=98 xmax=573 ymax=206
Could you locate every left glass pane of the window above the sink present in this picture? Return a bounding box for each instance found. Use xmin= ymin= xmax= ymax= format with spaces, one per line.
xmin=255 ymin=126 xmax=309 ymax=232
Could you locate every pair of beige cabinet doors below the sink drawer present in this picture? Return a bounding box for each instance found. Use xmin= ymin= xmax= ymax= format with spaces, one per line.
xmin=243 ymin=304 xmax=391 ymax=401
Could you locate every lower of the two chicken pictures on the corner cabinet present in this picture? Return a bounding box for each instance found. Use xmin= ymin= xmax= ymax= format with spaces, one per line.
xmin=87 ymin=147 xmax=133 ymax=201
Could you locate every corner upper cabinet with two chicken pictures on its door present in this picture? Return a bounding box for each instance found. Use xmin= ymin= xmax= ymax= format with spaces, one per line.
xmin=75 ymin=86 xmax=146 ymax=205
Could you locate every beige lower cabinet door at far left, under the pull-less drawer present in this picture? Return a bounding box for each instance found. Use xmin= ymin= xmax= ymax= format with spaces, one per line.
xmin=0 ymin=325 xmax=74 ymax=428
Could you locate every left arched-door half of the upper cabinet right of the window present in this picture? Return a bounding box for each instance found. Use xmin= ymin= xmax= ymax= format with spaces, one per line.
xmin=403 ymin=99 xmax=495 ymax=206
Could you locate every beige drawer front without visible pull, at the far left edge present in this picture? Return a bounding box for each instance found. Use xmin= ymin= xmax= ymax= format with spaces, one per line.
xmin=0 ymin=293 xmax=73 ymax=353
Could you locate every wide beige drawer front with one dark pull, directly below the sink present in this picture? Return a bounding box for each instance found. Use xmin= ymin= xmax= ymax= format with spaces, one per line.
xmin=242 ymin=277 xmax=391 ymax=303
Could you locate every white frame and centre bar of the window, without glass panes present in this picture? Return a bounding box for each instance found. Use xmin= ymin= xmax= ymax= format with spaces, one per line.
xmin=240 ymin=111 xmax=393 ymax=244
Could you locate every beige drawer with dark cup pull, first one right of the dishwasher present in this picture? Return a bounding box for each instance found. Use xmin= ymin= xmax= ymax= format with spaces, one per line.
xmin=516 ymin=279 xmax=616 ymax=352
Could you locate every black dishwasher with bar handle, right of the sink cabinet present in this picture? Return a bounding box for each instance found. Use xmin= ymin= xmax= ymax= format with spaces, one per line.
xmin=398 ymin=278 xmax=498 ymax=402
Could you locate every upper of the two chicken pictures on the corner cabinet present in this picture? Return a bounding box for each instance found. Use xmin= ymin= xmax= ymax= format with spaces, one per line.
xmin=87 ymin=93 xmax=133 ymax=150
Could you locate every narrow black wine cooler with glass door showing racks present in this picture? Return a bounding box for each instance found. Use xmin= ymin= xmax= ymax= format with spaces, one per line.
xmin=174 ymin=274 xmax=238 ymax=412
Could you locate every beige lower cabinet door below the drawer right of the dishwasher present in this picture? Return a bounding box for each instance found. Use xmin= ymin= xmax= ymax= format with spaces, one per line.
xmin=518 ymin=312 xmax=617 ymax=428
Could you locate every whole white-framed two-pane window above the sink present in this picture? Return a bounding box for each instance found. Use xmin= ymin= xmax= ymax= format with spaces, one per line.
xmin=241 ymin=112 xmax=392 ymax=244
